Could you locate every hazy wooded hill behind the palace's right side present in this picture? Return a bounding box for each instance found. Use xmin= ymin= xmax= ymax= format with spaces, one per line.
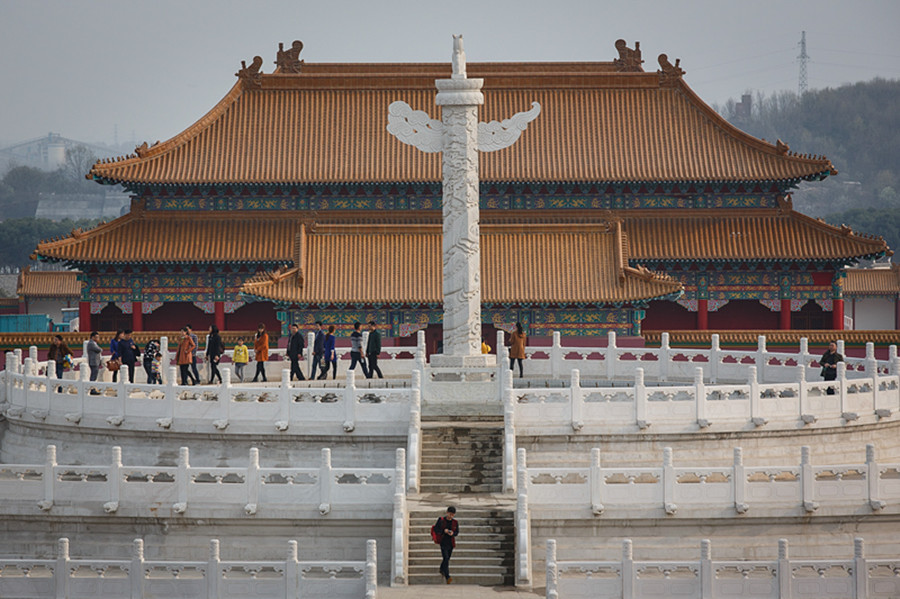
xmin=715 ymin=79 xmax=900 ymax=258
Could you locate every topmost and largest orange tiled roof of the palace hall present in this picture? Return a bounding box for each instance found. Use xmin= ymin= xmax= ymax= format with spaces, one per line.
xmin=88 ymin=49 xmax=836 ymax=185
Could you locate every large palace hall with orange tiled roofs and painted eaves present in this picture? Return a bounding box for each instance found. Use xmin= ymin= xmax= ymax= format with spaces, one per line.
xmin=35 ymin=40 xmax=890 ymax=341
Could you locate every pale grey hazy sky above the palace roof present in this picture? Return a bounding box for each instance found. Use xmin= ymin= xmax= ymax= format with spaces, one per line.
xmin=0 ymin=0 xmax=900 ymax=147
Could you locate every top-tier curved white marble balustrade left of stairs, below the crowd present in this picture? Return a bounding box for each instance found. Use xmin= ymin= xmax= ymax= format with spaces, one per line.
xmin=4 ymin=358 xmax=411 ymax=435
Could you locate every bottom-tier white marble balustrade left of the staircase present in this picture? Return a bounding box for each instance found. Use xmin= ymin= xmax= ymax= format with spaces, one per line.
xmin=0 ymin=538 xmax=378 ymax=599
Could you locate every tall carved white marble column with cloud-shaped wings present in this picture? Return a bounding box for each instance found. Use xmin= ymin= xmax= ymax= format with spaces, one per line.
xmin=387 ymin=35 xmax=541 ymax=366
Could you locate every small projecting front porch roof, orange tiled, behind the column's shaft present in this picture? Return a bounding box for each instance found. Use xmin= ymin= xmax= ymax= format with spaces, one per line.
xmin=241 ymin=224 xmax=682 ymax=305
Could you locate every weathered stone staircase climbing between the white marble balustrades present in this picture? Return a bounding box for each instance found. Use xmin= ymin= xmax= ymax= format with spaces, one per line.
xmin=409 ymin=421 xmax=515 ymax=586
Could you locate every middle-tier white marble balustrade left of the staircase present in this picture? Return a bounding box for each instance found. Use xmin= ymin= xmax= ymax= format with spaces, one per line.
xmin=0 ymin=445 xmax=406 ymax=520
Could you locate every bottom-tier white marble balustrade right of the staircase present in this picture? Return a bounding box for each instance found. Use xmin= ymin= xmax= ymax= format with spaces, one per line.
xmin=545 ymin=538 xmax=900 ymax=599
